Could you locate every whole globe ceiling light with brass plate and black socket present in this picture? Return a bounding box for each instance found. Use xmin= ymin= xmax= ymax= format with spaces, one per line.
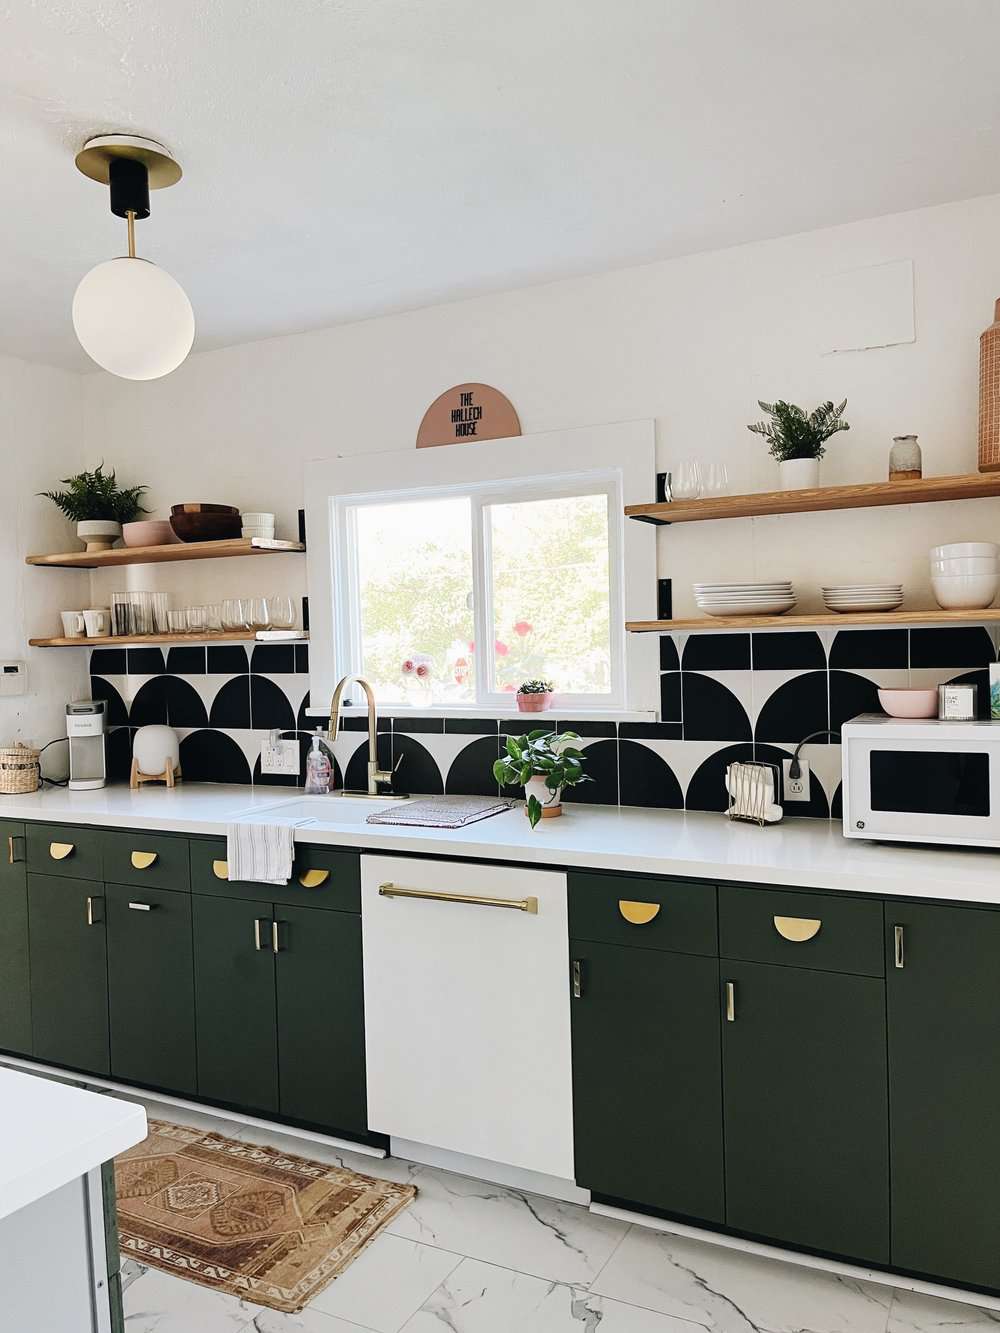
xmin=73 ymin=135 xmax=195 ymax=380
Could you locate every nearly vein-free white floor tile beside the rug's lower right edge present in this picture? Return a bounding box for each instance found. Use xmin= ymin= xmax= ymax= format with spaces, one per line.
xmin=309 ymin=1234 xmax=463 ymax=1333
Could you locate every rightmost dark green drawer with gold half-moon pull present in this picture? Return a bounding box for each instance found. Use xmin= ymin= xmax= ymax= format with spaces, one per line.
xmin=719 ymin=886 xmax=885 ymax=977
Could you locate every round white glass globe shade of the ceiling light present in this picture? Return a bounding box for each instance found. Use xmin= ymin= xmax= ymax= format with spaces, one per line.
xmin=73 ymin=256 xmax=195 ymax=380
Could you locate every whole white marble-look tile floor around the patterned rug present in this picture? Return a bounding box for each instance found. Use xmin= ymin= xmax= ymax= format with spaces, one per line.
xmin=109 ymin=1101 xmax=1000 ymax=1333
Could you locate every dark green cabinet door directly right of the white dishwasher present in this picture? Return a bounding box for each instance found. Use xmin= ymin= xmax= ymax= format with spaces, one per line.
xmin=571 ymin=940 xmax=724 ymax=1222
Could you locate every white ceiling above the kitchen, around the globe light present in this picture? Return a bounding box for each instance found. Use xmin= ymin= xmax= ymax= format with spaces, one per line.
xmin=0 ymin=0 xmax=1000 ymax=369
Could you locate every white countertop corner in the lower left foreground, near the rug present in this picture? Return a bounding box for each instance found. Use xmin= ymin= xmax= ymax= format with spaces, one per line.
xmin=0 ymin=1068 xmax=147 ymax=1217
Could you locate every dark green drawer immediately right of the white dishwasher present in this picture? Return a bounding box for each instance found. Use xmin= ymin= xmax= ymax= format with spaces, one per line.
xmin=569 ymin=872 xmax=719 ymax=957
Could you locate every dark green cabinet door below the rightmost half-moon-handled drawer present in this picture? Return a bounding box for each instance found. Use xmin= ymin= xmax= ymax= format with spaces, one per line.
xmin=721 ymin=961 xmax=890 ymax=1264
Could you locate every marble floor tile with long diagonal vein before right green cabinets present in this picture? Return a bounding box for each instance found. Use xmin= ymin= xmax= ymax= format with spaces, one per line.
xmin=591 ymin=1226 xmax=892 ymax=1333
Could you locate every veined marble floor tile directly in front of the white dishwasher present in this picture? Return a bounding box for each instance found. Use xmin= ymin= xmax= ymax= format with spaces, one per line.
xmin=389 ymin=1166 xmax=627 ymax=1286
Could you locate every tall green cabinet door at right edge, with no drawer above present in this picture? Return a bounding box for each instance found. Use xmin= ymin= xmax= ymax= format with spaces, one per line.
xmin=885 ymin=902 xmax=1000 ymax=1288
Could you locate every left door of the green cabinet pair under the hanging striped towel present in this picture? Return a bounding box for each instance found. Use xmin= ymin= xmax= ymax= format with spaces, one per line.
xmin=192 ymin=894 xmax=279 ymax=1112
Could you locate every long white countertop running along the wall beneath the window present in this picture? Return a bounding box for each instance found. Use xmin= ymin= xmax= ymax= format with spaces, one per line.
xmin=0 ymin=782 xmax=1000 ymax=904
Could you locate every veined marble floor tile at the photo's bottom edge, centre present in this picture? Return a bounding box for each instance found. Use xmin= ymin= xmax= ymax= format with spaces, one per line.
xmin=404 ymin=1260 xmax=699 ymax=1333
